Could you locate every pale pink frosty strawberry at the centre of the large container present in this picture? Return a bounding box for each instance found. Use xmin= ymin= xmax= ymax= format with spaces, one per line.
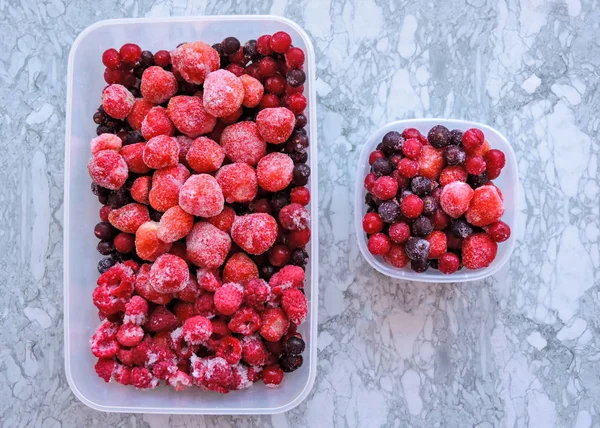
xmin=179 ymin=174 xmax=225 ymax=217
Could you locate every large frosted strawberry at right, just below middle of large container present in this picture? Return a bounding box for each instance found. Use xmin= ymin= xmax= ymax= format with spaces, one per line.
xmin=231 ymin=213 xmax=277 ymax=255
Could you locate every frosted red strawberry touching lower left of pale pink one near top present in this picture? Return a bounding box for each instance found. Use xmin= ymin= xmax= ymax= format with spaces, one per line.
xmin=167 ymin=95 xmax=217 ymax=138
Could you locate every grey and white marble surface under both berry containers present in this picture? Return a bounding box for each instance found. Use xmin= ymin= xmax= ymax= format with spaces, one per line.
xmin=0 ymin=0 xmax=600 ymax=428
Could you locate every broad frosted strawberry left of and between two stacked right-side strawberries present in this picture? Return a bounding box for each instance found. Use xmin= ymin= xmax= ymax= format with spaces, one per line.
xmin=221 ymin=122 xmax=267 ymax=166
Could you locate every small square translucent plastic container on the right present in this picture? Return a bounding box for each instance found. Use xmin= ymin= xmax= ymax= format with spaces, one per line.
xmin=354 ymin=118 xmax=519 ymax=283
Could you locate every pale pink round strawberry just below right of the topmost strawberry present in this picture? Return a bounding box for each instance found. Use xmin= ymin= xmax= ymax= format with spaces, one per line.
xmin=202 ymin=70 xmax=244 ymax=117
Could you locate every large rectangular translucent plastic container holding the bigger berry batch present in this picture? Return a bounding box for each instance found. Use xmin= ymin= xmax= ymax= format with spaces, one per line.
xmin=64 ymin=16 xmax=319 ymax=414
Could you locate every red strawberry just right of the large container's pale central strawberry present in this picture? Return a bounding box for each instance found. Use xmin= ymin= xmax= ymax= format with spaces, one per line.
xmin=215 ymin=163 xmax=258 ymax=204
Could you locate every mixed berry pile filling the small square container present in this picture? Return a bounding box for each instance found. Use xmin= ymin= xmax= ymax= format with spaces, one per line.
xmin=362 ymin=125 xmax=510 ymax=274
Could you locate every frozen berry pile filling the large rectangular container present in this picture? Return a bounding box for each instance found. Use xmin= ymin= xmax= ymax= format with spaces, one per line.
xmin=88 ymin=32 xmax=310 ymax=393
